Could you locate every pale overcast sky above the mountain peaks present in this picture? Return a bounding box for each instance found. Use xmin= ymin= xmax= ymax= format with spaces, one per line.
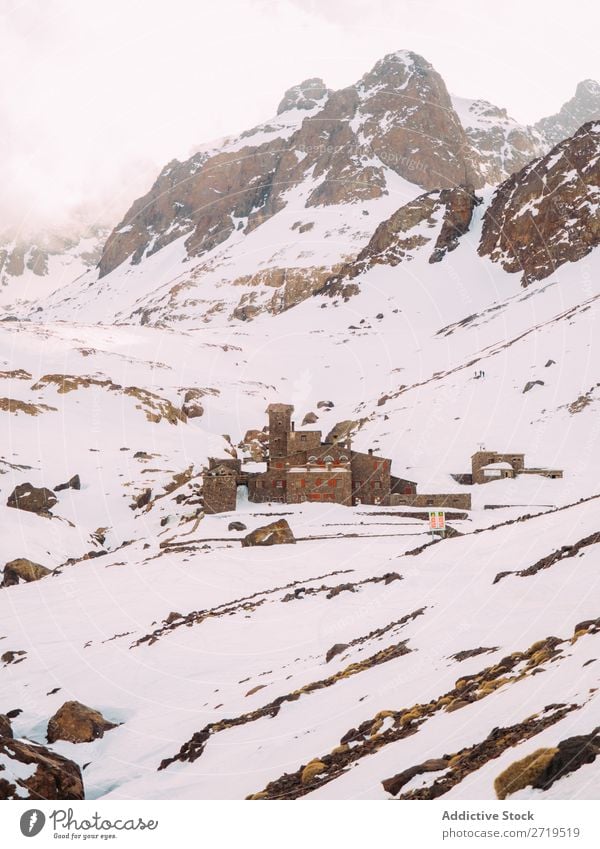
xmin=0 ymin=0 xmax=600 ymax=231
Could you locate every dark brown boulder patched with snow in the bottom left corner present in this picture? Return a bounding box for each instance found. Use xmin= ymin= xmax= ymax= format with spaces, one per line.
xmin=0 ymin=737 xmax=84 ymax=801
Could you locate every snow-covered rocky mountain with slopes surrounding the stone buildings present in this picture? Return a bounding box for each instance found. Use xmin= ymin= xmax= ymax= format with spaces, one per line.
xmin=0 ymin=46 xmax=600 ymax=799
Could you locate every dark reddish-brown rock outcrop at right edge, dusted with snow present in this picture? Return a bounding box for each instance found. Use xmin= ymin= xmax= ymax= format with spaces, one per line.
xmin=479 ymin=122 xmax=600 ymax=286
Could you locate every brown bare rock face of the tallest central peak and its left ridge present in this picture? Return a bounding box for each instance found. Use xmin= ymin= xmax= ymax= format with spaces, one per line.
xmin=99 ymin=51 xmax=483 ymax=278
